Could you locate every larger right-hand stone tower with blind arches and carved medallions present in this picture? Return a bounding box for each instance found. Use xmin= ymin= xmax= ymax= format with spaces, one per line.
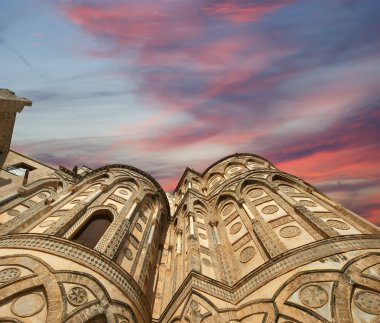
xmin=153 ymin=154 xmax=380 ymax=323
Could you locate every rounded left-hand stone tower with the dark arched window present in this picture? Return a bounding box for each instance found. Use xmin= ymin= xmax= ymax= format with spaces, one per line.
xmin=0 ymin=165 xmax=170 ymax=323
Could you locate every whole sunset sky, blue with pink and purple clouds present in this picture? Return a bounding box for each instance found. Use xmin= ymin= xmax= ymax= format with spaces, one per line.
xmin=0 ymin=0 xmax=380 ymax=224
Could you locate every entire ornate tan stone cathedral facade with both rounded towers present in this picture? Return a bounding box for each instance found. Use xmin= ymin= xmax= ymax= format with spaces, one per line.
xmin=0 ymin=90 xmax=380 ymax=323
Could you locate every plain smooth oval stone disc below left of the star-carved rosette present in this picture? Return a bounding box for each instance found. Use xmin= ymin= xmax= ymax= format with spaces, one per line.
xmin=11 ymin=293 xmax=45 ymax=317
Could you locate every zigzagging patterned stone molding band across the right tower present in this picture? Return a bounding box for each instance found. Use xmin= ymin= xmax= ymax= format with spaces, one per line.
xmin=159 ymin=235 xmax=380 ymax=322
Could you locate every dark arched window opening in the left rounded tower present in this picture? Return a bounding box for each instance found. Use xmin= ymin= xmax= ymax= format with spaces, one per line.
xmin=72 ymin=213 xmax=112 ymax=248
